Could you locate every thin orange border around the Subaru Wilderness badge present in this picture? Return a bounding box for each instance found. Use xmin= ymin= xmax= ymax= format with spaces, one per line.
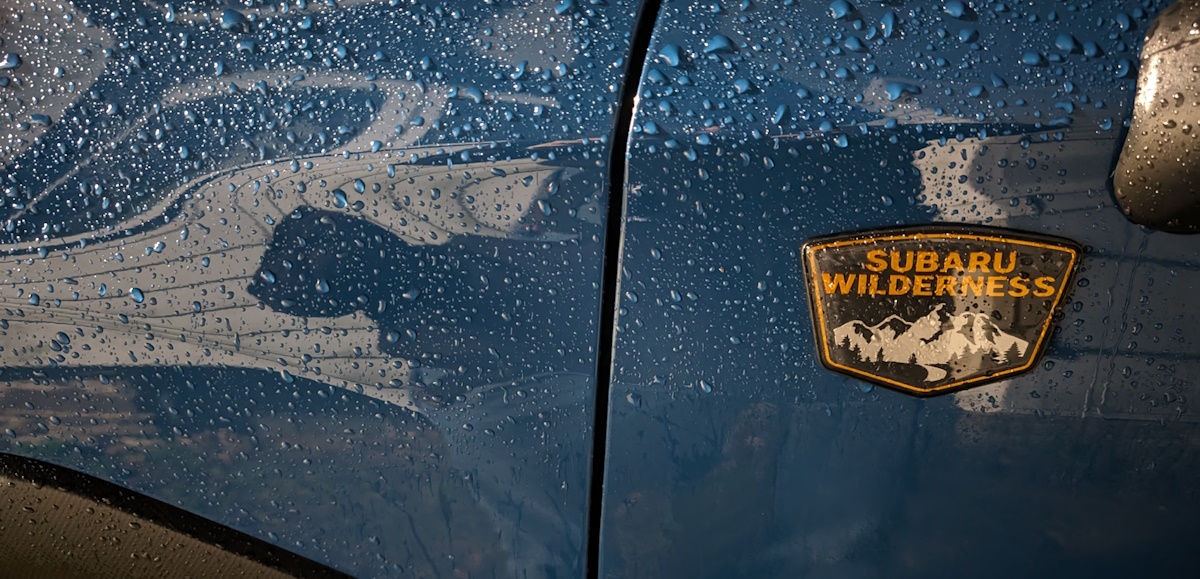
xmin=800 ymin=225 xmax=1082 ymax=396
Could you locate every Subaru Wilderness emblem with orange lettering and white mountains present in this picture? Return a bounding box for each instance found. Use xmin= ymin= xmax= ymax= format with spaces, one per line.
xmin=803 ymin=226 xmax=1080 ymax=394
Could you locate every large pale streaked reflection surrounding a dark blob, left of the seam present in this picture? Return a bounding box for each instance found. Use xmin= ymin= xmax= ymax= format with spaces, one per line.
xmin=0 ymin=147 xmax=585 ymax=406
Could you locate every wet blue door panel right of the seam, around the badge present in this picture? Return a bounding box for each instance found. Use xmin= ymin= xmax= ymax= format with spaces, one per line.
xmin=600 ymin=0 xmax=1200 ymax=578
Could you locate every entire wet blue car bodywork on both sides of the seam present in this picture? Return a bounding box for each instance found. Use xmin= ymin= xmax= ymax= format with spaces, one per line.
xmin=0 ymin=0 xmax=1200 ymax=578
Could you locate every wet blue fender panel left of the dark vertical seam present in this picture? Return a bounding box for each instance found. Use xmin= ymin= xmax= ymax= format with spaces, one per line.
xmin=0 ymin=0 xmax=637 ymax=577
